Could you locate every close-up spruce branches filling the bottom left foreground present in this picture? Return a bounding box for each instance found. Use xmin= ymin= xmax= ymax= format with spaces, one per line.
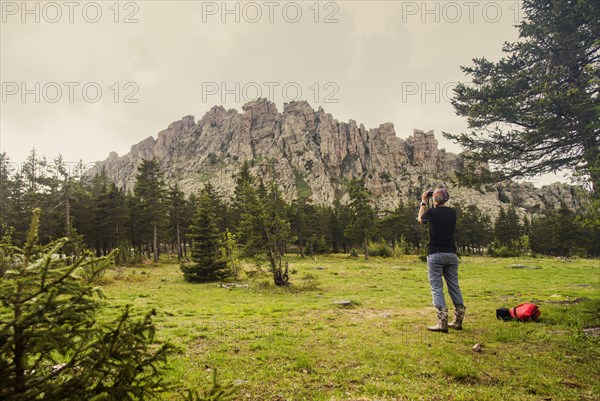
xmin=0 ymin=209 xmax=171 ymax=401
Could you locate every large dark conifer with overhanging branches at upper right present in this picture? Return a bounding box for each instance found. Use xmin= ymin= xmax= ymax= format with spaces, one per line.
xmin=444 ymin=0 xmax=600 ymax=194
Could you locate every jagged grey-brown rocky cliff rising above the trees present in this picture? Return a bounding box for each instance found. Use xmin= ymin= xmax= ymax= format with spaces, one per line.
xmin=89 ymin=99 xmax=578 ymax=215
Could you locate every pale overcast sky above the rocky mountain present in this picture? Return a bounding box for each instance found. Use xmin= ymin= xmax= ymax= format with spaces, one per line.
xmin=0 ymin=0 xmax=568 ymax=183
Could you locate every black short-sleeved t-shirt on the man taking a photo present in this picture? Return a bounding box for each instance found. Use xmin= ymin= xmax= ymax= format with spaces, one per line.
xmin=421 ymin=206 xmax=456 ymax=255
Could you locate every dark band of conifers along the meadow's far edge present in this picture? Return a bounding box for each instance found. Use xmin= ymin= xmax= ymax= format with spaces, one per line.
xmin=0 ymin=151 xmax=600 ymax=260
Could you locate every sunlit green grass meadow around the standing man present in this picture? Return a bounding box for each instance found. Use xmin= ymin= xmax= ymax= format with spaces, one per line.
xmin=96 ymin=255 xmax=600 ymax=401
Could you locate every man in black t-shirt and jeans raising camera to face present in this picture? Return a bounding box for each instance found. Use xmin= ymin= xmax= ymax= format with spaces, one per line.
xmin=417 ymin=188 xmax=466 ymax=333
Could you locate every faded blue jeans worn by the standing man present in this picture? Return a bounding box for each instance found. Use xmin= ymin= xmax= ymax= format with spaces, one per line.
xmin=427 ymin=253 xmax=464 ymax=308
